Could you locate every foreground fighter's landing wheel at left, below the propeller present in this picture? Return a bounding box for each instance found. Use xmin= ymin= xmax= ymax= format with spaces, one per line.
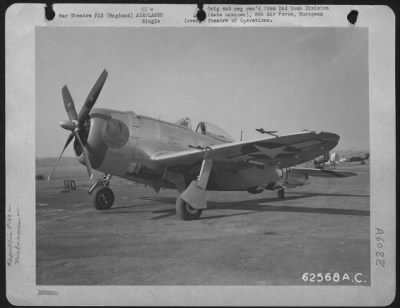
xmin=89 ymin=174 xmax=115 ymax=210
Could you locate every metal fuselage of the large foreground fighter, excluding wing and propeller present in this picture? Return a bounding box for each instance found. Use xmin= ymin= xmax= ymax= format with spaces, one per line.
xmin=75 ymin=109 xmax=290 ymax=190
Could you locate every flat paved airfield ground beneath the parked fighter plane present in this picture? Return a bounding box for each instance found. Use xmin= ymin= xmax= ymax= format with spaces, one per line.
xmin=36 ymin=163 xmax=370 ymax=285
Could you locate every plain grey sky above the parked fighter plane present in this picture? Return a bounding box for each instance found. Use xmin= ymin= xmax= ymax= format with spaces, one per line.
xmin=36 ymin=27 xmax=369 ymax=157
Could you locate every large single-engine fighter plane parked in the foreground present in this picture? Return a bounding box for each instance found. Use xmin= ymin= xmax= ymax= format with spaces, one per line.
xmin=49 ymin=70 xmax=354 ymax=220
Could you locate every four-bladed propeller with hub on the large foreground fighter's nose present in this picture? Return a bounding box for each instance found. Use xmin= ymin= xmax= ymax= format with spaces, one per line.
xmin=48 ymin=70 xmax=108 ymax=180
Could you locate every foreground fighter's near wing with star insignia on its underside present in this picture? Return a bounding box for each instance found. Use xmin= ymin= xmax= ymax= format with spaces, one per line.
xmin=152 ymin=132 xmax=339 ymax=168
